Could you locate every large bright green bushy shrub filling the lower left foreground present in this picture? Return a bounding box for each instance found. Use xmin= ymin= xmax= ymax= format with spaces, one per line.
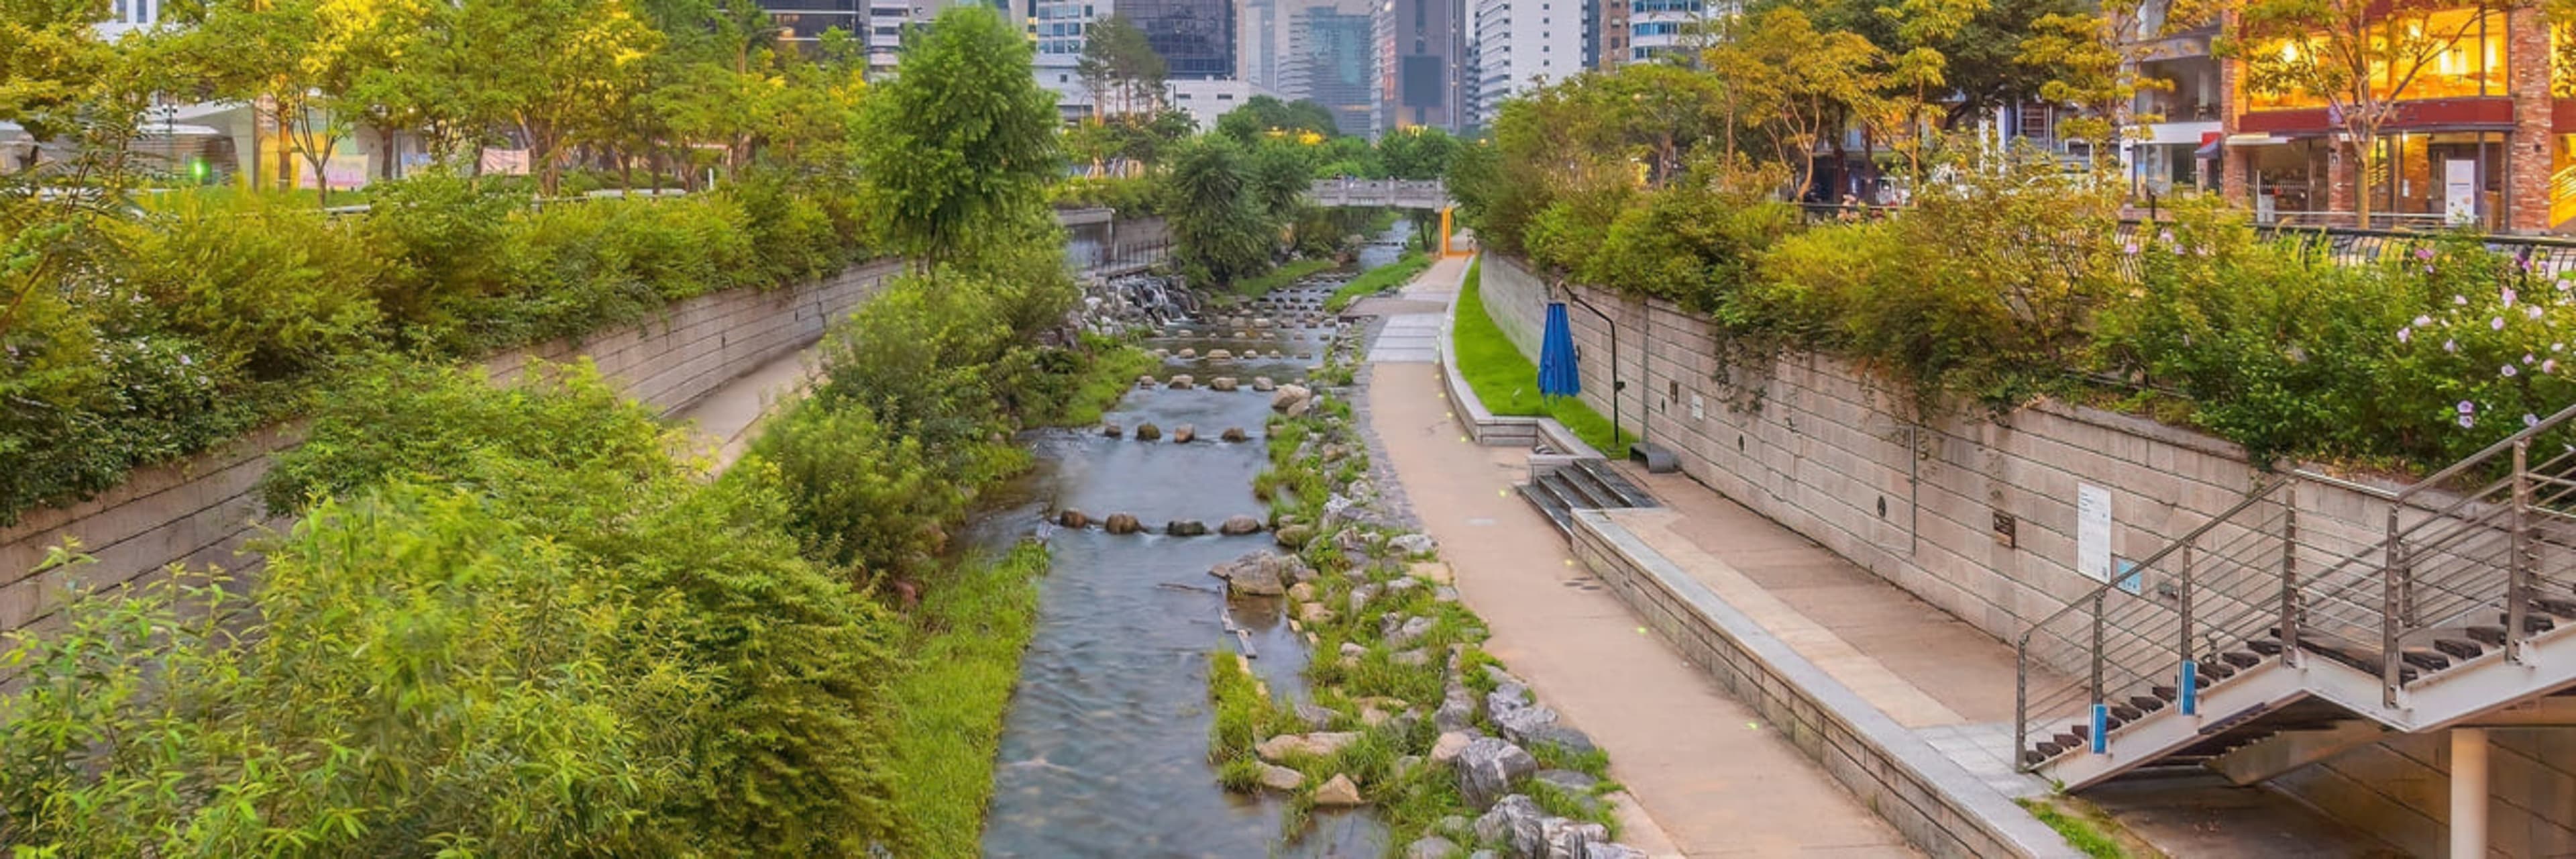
xmin=0 ymin=366 xmax=910 ymax=856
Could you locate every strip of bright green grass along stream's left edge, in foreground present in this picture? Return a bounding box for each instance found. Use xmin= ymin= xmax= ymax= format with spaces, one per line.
xmin=892 ymin=544 xmax=1049 ymax=856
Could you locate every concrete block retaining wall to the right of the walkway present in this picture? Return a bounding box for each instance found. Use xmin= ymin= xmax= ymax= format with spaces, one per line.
xmin=1481 ymin=256 xmax=2576 ymax=856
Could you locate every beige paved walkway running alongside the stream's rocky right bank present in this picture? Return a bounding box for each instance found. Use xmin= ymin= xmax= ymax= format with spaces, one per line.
xmin=1368 ymin=260 xmax=1914 ymax=856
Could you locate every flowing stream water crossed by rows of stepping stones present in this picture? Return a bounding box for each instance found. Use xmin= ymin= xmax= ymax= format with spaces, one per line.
xmin=971 ymin=237 xmax=1393 ymax=856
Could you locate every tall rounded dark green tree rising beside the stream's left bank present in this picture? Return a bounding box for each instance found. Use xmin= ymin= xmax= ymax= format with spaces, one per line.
xmin=861 ymin=5 xmax=1059 ymax=268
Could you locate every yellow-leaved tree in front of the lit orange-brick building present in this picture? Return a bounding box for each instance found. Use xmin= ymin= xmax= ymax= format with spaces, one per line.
xmin=2200 ymin=0 xmax=2524 ymax=227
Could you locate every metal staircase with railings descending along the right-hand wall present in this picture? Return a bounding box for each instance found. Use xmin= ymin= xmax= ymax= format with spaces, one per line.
xmin=2015 ymin=407 xmax=2576 ymax=789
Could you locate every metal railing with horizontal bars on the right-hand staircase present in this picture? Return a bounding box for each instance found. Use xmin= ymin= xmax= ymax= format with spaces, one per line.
xmin=2015 ymin=399 xmax=2576 ymax=768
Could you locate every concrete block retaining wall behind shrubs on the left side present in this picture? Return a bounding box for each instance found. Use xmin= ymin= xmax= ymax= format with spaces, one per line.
xmin=0 ymin=260 xmax=902 ymax=632
